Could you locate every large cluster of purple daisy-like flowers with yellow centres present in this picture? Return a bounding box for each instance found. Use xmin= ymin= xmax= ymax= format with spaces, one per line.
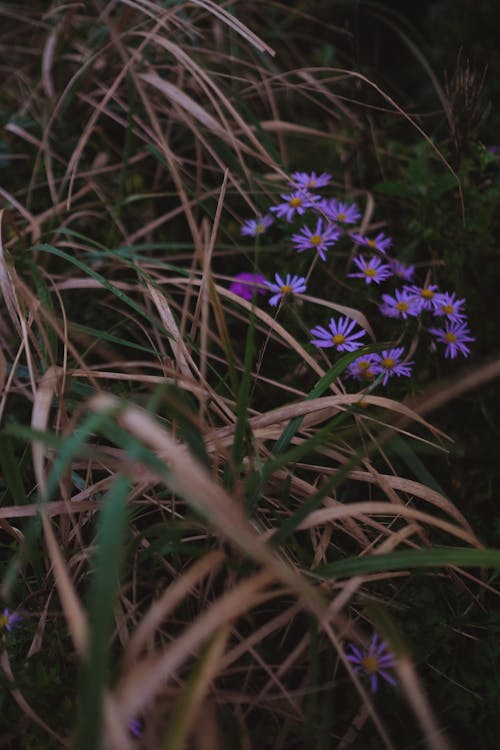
xmin=229 ymin=172 xmax=474 ymax=385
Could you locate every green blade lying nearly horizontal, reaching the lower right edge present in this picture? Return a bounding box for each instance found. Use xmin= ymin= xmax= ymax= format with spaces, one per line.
xmin=311 ymin=547 xmax=500 ymax=580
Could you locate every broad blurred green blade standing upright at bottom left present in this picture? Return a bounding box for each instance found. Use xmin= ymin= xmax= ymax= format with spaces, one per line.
xmin=75 ymin=476 xmax=129 ymax=750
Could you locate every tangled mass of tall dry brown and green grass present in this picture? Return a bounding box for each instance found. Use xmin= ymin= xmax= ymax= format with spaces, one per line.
xmin=0 ymin=0 xmax=500 ymax=750
